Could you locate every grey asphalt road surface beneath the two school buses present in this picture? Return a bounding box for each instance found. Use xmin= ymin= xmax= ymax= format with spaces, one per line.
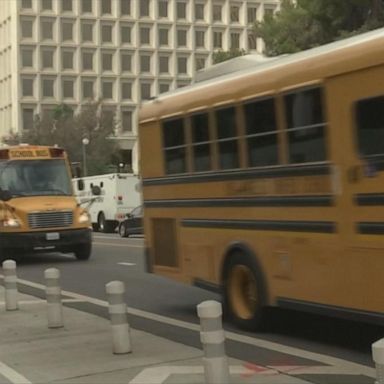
xmin=6 ymin=234 xmax=384 ymax=366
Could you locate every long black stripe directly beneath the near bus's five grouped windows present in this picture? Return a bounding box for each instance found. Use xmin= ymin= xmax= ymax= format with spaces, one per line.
xmin=143 ymin=164 xmax=331 ymax=186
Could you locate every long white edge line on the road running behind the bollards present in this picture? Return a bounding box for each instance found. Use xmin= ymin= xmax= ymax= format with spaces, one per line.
xmin=0 ymin=275 xmax=376 ymax=378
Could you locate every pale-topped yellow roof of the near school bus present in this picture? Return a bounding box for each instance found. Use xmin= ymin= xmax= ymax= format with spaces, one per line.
xmin=139 ymin=28 xmax=384 ymax=122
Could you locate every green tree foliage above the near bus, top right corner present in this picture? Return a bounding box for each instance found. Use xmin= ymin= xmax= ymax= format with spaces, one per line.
xmin=255 ymin=0 xmax=384 ymax=56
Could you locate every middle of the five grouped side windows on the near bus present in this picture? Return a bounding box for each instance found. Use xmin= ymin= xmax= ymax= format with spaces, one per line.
xmin=215 ymin=107 xmax=239 ymax=169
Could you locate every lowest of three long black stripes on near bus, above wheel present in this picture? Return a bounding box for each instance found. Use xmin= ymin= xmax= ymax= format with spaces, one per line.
xmin=181 ymin=219 xmax=336 ymax=233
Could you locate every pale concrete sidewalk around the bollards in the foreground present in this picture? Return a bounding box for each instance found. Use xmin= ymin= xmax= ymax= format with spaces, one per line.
xmin=0 ymin=287 xmax=320 ymax=384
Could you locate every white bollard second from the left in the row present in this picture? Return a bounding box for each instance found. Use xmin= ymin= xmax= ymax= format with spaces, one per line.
xmin=44 ymin=268 xmax=64 ymax=328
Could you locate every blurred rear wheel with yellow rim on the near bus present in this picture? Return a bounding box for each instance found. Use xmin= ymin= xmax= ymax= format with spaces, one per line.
xmin=223 ymin=249 xmax=267 ymax=331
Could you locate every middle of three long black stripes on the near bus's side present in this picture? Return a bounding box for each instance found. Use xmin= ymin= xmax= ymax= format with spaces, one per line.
xmin=145 ymin=195 xmax=334 ymax=208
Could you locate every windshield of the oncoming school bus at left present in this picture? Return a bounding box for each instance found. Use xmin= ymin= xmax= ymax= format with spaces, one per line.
xmin=0 ymin=159 xmax=72 ymax=197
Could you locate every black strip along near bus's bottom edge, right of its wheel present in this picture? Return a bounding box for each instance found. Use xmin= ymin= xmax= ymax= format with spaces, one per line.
xmin=277 ymin=297 xmax=384 ymax=325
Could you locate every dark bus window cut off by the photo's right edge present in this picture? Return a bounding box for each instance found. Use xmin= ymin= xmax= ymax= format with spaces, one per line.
xmin=356 ymin=96 xmax=384 ymax=156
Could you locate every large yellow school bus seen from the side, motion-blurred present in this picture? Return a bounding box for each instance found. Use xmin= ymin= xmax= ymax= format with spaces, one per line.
xmin=139 ymin=29 xmax=384 ymax=329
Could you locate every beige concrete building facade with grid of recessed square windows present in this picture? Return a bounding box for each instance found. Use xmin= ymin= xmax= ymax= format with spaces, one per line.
xmin=0 ymin=0 xmax=280 ymax=153
